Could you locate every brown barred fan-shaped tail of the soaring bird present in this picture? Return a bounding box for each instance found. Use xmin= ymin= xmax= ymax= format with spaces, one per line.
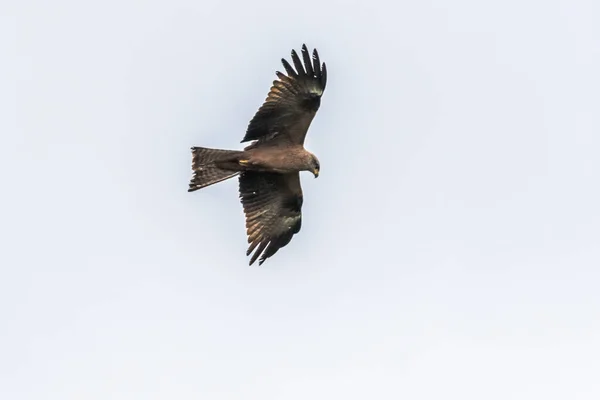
xmin=188 ymin=147 xmax=243 ymax=192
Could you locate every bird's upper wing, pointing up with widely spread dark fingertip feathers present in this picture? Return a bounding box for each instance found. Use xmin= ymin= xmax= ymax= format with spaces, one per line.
xmin=242 ymin=45 xmax=327 ymax=144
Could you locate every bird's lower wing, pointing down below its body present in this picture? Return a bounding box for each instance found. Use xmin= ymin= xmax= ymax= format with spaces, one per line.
xmin=239 ymin=171 xmax=302 ymax=265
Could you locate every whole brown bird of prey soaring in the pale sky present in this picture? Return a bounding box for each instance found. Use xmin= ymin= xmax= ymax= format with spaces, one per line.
xmin=188 ymin=45 xmax=327 ymax=265
